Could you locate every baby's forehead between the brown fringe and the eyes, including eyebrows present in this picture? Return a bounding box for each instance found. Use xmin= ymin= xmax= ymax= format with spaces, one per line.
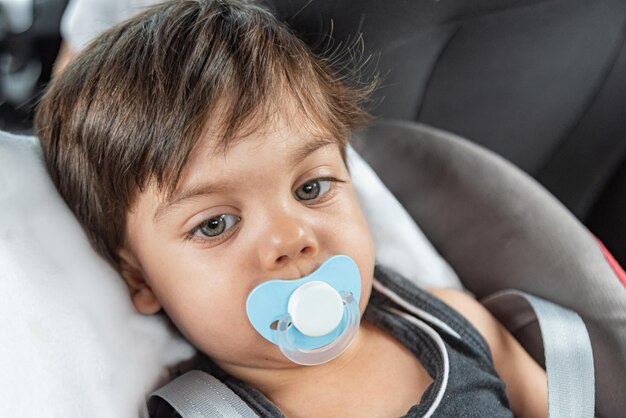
xmin=148 ymin=105 xmax=345 ymax=220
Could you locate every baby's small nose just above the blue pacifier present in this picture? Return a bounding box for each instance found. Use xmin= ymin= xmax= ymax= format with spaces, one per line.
xmin=259 ymin=208 xmax=319 ymax=271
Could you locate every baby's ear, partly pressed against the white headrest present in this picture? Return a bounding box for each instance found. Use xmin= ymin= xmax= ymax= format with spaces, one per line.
xmin=118 ymin=248 xmax=161 ymax=315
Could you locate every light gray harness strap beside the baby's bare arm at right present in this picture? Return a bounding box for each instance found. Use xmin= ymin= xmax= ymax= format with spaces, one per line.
xmin=483 ymin=290 xmax=595 ymax=418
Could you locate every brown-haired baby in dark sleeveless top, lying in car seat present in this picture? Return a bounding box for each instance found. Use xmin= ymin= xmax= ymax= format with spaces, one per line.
xmin=36 ymin=0 xmax=547 ymax=417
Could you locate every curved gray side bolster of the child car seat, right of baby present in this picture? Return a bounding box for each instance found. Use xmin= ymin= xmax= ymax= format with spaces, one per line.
xmin=354 ymin=117 xmax=626 ymax=417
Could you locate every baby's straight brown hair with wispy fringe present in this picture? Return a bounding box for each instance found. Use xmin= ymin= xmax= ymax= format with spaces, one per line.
xmin=35 ymin=0 xmax=372 ymax=267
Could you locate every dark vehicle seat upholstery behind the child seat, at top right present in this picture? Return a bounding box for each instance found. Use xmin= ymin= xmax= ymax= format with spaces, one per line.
xmin=269 ymin=0 xmax=626 ymax=263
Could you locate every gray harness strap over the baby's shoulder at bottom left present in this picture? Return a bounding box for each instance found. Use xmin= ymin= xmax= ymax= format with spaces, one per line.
xmin=150 ymin=370 xmax=258 ymax=418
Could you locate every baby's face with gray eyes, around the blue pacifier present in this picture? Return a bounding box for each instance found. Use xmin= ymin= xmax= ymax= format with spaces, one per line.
xmin=120 ymin=112 xmax=374 ymax=367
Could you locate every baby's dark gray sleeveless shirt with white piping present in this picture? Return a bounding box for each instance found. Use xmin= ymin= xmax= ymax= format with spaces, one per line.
xmin=150 ymin=267 xmax=512 ymax=418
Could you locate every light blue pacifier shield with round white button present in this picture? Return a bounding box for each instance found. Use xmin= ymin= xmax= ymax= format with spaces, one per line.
xmin=246 ymin=255 xmax=361 ymax=350
